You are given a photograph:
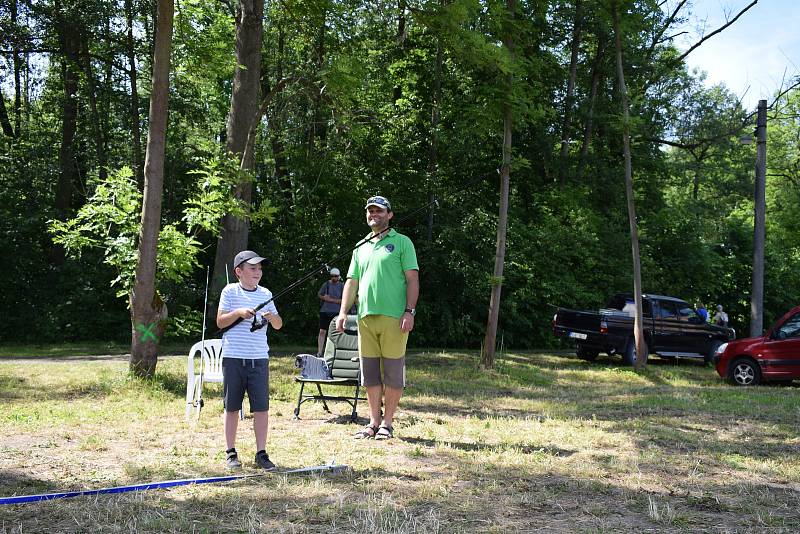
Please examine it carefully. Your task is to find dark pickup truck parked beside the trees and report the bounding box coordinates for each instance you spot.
[553,293,736,365]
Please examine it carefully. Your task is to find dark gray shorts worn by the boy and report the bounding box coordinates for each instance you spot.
[222,357,269,412]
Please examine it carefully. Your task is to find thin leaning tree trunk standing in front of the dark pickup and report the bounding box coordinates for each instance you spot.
[612,1,647,370]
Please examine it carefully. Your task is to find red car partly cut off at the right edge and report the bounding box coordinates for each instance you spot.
[712,306,800,386]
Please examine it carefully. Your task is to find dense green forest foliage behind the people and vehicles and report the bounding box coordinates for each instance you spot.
[0,0,800,358]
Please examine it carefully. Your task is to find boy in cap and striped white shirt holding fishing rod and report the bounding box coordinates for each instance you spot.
[217,250,283,470]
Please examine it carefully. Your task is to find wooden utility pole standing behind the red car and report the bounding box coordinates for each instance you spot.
[750,100,767,337]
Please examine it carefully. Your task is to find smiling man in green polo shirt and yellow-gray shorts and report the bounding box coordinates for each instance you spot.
[336,196,419,439]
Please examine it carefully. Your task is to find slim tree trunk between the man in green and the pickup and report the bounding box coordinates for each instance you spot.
[481,0,517,369]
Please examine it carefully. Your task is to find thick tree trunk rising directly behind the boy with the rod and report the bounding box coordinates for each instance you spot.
[211,0,264,302]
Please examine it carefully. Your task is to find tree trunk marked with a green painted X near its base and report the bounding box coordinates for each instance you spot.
[130,0,175,377]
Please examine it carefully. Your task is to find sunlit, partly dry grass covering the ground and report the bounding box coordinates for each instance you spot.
[0,349,800,533]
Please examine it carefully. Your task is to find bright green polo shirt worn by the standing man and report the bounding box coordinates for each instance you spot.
[347,229,419,319]
